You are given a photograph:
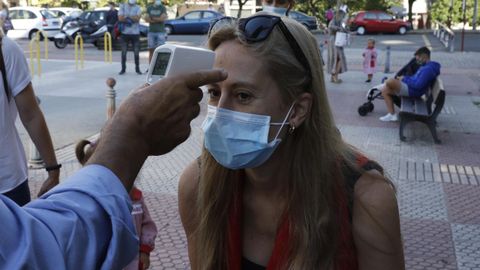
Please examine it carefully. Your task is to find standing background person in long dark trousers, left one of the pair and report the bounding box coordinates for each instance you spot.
[118,0,142,75]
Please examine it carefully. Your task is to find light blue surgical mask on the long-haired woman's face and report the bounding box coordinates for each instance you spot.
[202,104,294,170]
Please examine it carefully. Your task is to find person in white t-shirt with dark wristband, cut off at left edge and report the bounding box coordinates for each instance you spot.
[0,34,61,206]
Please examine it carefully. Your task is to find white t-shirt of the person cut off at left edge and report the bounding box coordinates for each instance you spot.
[0,37,31,193]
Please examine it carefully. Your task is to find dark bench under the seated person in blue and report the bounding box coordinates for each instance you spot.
[399,77,445,143]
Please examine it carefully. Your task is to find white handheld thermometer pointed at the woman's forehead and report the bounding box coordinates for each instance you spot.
[147,44,215,84]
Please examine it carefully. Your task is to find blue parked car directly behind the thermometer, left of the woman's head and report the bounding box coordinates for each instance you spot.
[165,10,224,34]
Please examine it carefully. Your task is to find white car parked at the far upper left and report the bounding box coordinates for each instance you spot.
[8,7,62,39]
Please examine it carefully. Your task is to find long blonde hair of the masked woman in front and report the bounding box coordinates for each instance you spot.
[194,17,376,269]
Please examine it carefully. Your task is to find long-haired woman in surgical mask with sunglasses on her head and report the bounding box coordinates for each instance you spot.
[179,14,404,270]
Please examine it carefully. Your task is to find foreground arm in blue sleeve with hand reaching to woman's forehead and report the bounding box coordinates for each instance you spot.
[0,70,227,270]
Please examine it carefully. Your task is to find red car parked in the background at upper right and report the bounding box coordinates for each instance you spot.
[349,11,411,35]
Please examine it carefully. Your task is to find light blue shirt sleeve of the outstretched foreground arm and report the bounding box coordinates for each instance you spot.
[0,165,139,270]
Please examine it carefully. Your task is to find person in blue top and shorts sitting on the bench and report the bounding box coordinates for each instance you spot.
[380,47,440,122]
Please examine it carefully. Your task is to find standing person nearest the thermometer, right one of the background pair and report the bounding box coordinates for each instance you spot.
[145,0,168,63]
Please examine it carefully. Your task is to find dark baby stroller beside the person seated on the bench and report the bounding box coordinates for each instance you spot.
[358,57,420,116]
